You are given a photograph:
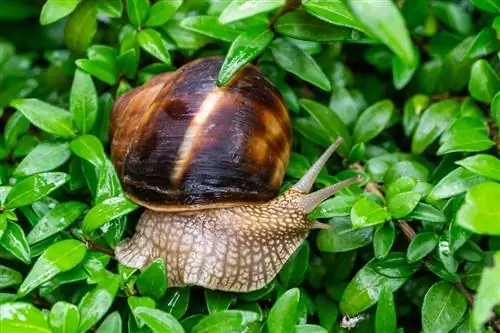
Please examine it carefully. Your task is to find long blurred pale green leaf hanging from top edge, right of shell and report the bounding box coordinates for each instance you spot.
[348,0,417,66]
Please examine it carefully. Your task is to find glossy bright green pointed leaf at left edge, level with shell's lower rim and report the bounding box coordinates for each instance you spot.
[5,172,69,208]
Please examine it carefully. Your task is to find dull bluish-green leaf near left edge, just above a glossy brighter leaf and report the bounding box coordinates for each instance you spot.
[12,142,71,178]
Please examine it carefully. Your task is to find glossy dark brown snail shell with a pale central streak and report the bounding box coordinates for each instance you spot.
[110,57,291,211]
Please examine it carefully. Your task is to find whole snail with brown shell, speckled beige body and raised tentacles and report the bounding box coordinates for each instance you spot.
[110,57,359,292]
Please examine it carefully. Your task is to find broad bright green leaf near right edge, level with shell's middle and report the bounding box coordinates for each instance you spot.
[437,117,495,155]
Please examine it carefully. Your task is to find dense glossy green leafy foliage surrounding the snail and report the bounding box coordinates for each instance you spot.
[0,0,500,333]
